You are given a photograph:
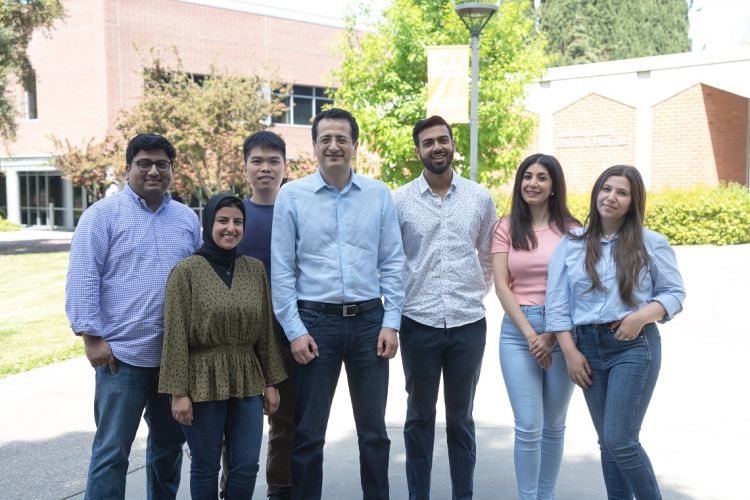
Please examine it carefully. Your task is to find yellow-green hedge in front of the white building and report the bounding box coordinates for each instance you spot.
[494,183,750,245]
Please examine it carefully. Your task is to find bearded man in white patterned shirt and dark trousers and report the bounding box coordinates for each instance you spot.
[393,116,497,500]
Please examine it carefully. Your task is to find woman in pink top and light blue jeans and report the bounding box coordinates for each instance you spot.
[492,154,580,500]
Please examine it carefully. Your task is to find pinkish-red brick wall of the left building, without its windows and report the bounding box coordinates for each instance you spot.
[11,0,342,156]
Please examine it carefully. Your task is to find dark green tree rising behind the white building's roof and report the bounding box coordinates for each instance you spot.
[540,0,690,66]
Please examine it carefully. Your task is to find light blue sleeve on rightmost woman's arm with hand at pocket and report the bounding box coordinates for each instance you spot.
[649,235,685,323]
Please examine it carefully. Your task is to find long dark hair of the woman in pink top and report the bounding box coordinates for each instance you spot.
[509,153,580,250]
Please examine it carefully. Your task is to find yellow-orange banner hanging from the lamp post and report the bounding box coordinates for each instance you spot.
[427,45,469,123]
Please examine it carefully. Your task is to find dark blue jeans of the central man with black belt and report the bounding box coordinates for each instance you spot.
[292,306,391,499]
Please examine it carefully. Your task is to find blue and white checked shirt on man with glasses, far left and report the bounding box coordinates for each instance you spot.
[65,185,201,367]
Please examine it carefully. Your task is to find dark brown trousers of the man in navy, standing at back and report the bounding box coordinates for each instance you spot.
[266,327,296,497]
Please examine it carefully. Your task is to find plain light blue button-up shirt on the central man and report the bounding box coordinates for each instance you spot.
[271,171,404,341]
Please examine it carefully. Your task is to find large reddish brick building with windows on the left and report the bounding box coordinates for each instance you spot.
[0,0,342,228]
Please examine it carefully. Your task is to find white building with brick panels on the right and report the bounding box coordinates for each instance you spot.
[526,48,750,191]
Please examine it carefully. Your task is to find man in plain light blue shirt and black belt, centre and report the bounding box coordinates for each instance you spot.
[271,108,404,499]
